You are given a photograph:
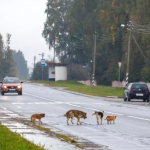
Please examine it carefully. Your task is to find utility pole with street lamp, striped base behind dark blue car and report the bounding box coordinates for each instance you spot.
[126,21,131,86]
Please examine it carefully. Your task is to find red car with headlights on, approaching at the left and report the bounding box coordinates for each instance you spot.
[0,77,23,95]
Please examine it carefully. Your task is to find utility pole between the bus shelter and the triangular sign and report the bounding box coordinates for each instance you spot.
[92,32,97,86]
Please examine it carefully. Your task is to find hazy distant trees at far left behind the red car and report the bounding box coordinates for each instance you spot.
[0,34,28,80]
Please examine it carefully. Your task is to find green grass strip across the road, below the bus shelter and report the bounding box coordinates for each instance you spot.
[32,81,124,97]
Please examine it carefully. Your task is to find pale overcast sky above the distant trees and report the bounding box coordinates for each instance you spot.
[0,0,53,67]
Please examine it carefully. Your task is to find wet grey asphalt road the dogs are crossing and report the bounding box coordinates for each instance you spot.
[0,84,150,150]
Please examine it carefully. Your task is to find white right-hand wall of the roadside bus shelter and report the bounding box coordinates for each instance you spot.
[55,66,67,81]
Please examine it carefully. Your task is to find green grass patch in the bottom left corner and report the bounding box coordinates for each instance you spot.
[0,124,44,150]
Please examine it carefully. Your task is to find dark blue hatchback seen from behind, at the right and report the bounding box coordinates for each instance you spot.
[124,83,149,102]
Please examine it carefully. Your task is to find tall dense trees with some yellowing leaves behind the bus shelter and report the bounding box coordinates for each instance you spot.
[42,0,150,85]
